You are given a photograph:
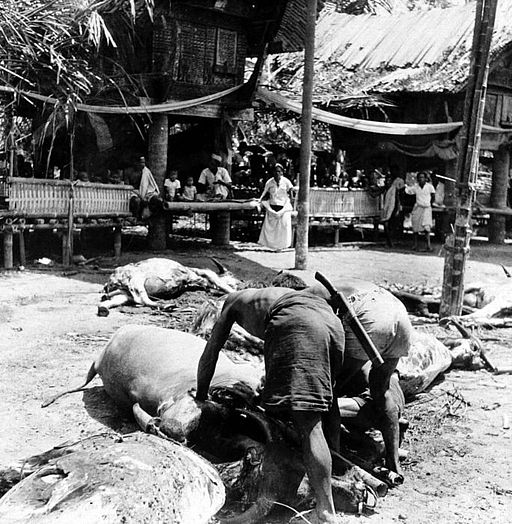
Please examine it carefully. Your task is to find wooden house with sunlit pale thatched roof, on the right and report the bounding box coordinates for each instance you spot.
[267,0,512,242]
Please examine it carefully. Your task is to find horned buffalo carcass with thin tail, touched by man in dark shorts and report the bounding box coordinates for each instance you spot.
[43,326,367,523]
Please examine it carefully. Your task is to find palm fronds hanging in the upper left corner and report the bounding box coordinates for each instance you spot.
[0,0,153,100]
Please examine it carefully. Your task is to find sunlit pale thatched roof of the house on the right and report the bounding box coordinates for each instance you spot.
[269,0,512,102]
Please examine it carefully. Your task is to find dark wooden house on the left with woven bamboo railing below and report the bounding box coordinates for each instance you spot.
[0,0,322,267]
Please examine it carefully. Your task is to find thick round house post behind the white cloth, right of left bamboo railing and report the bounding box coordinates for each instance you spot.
[148,113,169,251]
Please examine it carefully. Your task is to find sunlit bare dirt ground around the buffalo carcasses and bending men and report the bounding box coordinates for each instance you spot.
[0,235,512,524]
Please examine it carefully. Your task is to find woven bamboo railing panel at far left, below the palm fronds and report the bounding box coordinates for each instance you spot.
[8,178,133,218]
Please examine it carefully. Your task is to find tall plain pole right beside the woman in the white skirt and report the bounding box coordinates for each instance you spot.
[295,0,317,269]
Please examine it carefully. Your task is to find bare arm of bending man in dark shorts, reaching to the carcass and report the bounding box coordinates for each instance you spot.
[196,306,235,401]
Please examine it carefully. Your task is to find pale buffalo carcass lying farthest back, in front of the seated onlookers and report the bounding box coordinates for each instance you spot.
[98,258,240,316]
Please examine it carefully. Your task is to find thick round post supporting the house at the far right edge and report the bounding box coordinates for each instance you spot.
[489,146,510,244]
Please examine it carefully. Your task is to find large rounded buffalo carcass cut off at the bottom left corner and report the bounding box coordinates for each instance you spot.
[0,432,225,524]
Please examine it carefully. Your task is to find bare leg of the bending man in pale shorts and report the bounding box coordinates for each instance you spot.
[369,358,402,475]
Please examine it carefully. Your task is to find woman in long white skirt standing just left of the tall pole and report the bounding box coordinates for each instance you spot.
[258,163,293,249]
